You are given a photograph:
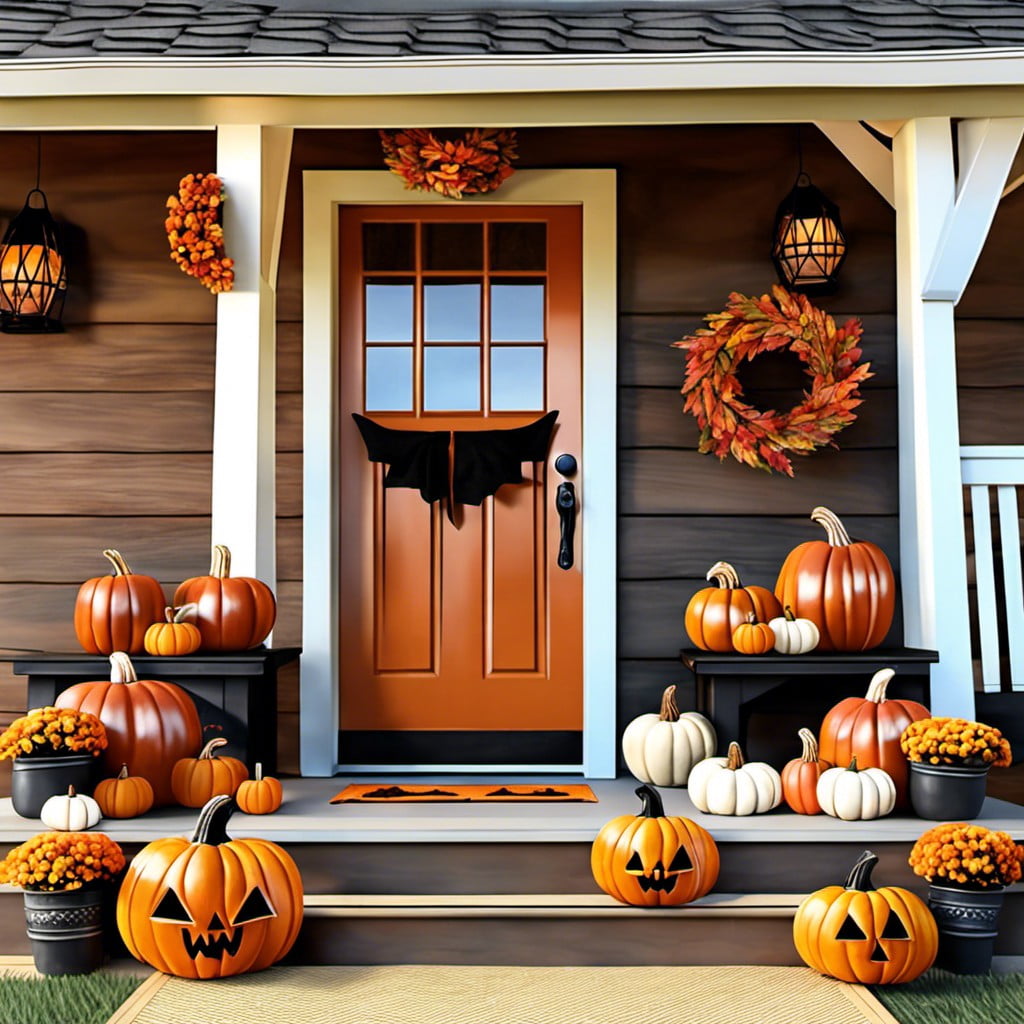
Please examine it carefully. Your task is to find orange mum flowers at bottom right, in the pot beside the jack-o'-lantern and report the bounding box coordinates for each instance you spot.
[908,821,1024,889]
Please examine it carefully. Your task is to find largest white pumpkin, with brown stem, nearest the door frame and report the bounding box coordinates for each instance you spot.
[623,686,718,785]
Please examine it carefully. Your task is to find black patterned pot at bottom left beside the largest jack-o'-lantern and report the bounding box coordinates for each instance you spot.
[25,888,103,974]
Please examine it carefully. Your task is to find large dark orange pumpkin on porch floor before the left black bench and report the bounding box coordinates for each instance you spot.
[55,651,203,807]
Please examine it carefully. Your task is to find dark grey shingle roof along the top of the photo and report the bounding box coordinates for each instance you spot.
[8,0,1024,58]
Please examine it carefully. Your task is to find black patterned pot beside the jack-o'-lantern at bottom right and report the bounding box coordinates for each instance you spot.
[928,886,1002,974]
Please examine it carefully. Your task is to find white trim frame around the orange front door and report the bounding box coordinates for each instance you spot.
[299,169,617,778]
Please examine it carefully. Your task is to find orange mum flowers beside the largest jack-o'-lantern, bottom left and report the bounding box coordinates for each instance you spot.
[0,831,125,892]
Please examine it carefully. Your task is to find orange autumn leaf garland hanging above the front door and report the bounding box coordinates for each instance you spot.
[380,128,518,199]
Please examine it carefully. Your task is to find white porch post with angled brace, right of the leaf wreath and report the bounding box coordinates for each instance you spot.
[893,118,1022,717]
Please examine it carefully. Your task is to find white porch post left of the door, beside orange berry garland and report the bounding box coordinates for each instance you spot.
[211,125,292,588]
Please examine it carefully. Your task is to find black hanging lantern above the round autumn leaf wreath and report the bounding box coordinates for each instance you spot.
[771,170,846,295]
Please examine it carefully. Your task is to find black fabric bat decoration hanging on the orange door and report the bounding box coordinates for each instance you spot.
[352,409,558,522]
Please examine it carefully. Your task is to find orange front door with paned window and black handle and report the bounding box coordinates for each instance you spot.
[339,203,585,764]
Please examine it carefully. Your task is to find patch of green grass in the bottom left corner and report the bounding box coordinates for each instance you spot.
[0,974,142,1024]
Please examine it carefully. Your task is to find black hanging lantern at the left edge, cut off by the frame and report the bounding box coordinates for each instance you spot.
[0,187,68,334]
